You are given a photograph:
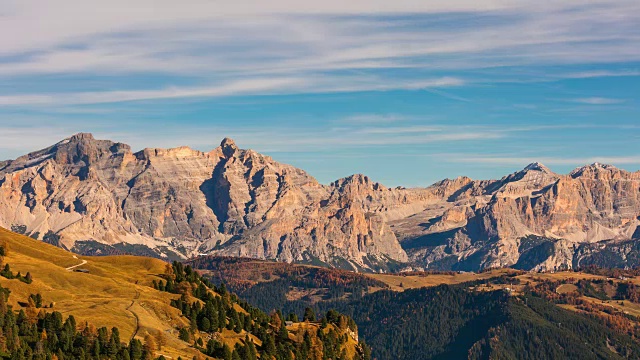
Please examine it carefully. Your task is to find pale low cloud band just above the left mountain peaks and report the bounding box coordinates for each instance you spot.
[0,122,508,155]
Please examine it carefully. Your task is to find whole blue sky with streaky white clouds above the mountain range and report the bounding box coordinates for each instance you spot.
[0,0,640,186]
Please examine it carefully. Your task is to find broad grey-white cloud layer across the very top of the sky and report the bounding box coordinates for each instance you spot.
[0,0,640,80]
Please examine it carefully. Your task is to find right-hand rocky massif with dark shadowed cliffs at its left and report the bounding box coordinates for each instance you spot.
[392,163,640,270]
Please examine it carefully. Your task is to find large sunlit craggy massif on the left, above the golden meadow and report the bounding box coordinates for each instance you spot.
[0,134,408,269]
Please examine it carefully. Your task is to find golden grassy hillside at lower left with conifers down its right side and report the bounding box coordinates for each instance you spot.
[0,228,362,360]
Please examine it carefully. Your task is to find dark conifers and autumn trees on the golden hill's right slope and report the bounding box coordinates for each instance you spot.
[153,263,365,360]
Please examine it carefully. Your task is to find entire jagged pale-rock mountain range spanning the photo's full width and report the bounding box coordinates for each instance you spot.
[0,134,640,270]
